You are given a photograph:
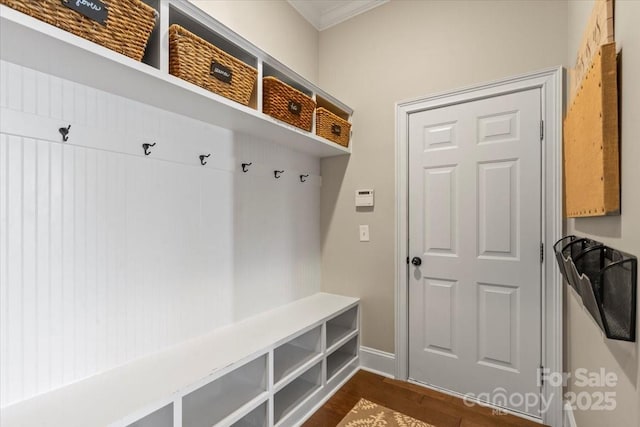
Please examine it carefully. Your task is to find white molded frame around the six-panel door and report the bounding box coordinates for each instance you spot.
[395,67,563,427]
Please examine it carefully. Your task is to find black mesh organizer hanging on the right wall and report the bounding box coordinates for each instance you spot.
[553,236,638,342]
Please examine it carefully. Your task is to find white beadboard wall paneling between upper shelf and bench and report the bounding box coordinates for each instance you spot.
[0,61,321,407]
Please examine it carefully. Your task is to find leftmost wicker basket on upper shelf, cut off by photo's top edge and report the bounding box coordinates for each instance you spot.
[0,0,156,61]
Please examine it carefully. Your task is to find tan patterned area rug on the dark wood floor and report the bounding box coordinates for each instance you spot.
[337,399,434,427]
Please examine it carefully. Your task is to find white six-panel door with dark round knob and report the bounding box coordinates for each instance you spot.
[409,89,542,417]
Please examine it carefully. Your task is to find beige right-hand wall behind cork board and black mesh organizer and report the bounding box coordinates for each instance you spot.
[565,0,640,427]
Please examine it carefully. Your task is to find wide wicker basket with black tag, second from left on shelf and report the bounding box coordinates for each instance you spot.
[169,24,258,105]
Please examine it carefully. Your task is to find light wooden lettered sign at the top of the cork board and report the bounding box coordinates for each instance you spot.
[568,0,614,105]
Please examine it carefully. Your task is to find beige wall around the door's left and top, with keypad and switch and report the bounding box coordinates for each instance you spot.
[319,1,567,353]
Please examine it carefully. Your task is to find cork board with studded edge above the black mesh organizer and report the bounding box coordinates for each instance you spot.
[564,43,620,217]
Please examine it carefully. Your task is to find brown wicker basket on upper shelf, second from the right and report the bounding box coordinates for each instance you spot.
[262,77,316,132]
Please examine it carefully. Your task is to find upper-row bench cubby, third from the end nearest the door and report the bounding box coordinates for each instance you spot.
[182,354,267,427]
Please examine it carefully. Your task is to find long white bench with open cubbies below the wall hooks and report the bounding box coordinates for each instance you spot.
[0,293,359,427]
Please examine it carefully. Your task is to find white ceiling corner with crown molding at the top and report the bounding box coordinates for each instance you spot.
[287,0,389,31]
